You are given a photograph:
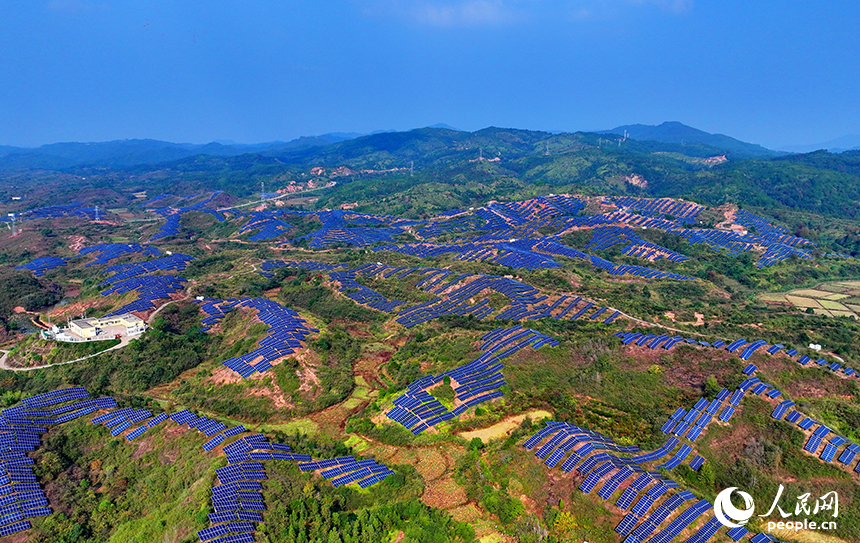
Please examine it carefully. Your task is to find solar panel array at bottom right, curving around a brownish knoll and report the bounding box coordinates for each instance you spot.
[523,377,860,543]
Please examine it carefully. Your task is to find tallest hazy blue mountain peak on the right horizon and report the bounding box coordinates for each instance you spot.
[600,121,784,156]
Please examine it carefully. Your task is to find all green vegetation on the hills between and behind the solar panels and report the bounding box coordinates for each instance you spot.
[0,128,860,543]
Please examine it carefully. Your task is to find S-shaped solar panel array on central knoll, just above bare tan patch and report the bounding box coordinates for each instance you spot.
[385,325,558,435]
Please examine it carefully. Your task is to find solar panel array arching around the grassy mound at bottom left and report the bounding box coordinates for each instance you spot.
[0,387,402,543]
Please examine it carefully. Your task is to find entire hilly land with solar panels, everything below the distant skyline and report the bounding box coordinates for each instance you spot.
[0,129,860,543]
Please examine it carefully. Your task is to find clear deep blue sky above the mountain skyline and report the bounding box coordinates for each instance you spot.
[0,0,860,147]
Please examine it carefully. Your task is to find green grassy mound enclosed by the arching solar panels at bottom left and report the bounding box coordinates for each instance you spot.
[36,420,218,543]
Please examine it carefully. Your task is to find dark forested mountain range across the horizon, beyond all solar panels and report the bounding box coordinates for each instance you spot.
[0,123,860,224]
